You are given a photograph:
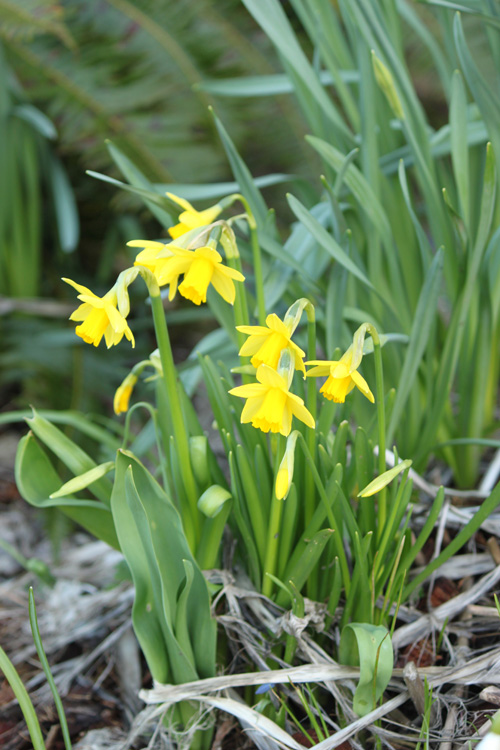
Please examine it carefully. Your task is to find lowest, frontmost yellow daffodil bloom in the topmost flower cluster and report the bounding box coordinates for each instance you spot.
[163,245,245,305]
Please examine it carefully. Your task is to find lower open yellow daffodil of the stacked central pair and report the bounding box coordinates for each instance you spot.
[229,365,315,436]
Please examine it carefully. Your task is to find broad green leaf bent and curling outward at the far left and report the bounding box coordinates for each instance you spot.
[15,433,120,549]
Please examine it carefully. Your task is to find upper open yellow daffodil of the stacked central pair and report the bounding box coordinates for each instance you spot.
[237,313,306,374]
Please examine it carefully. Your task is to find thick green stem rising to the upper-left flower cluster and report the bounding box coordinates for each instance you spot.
[150,290,200,552]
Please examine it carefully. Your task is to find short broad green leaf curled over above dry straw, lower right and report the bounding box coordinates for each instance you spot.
[339,622,394,716]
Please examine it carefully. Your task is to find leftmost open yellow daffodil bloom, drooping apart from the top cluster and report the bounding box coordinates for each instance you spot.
[63,279,135,349]
